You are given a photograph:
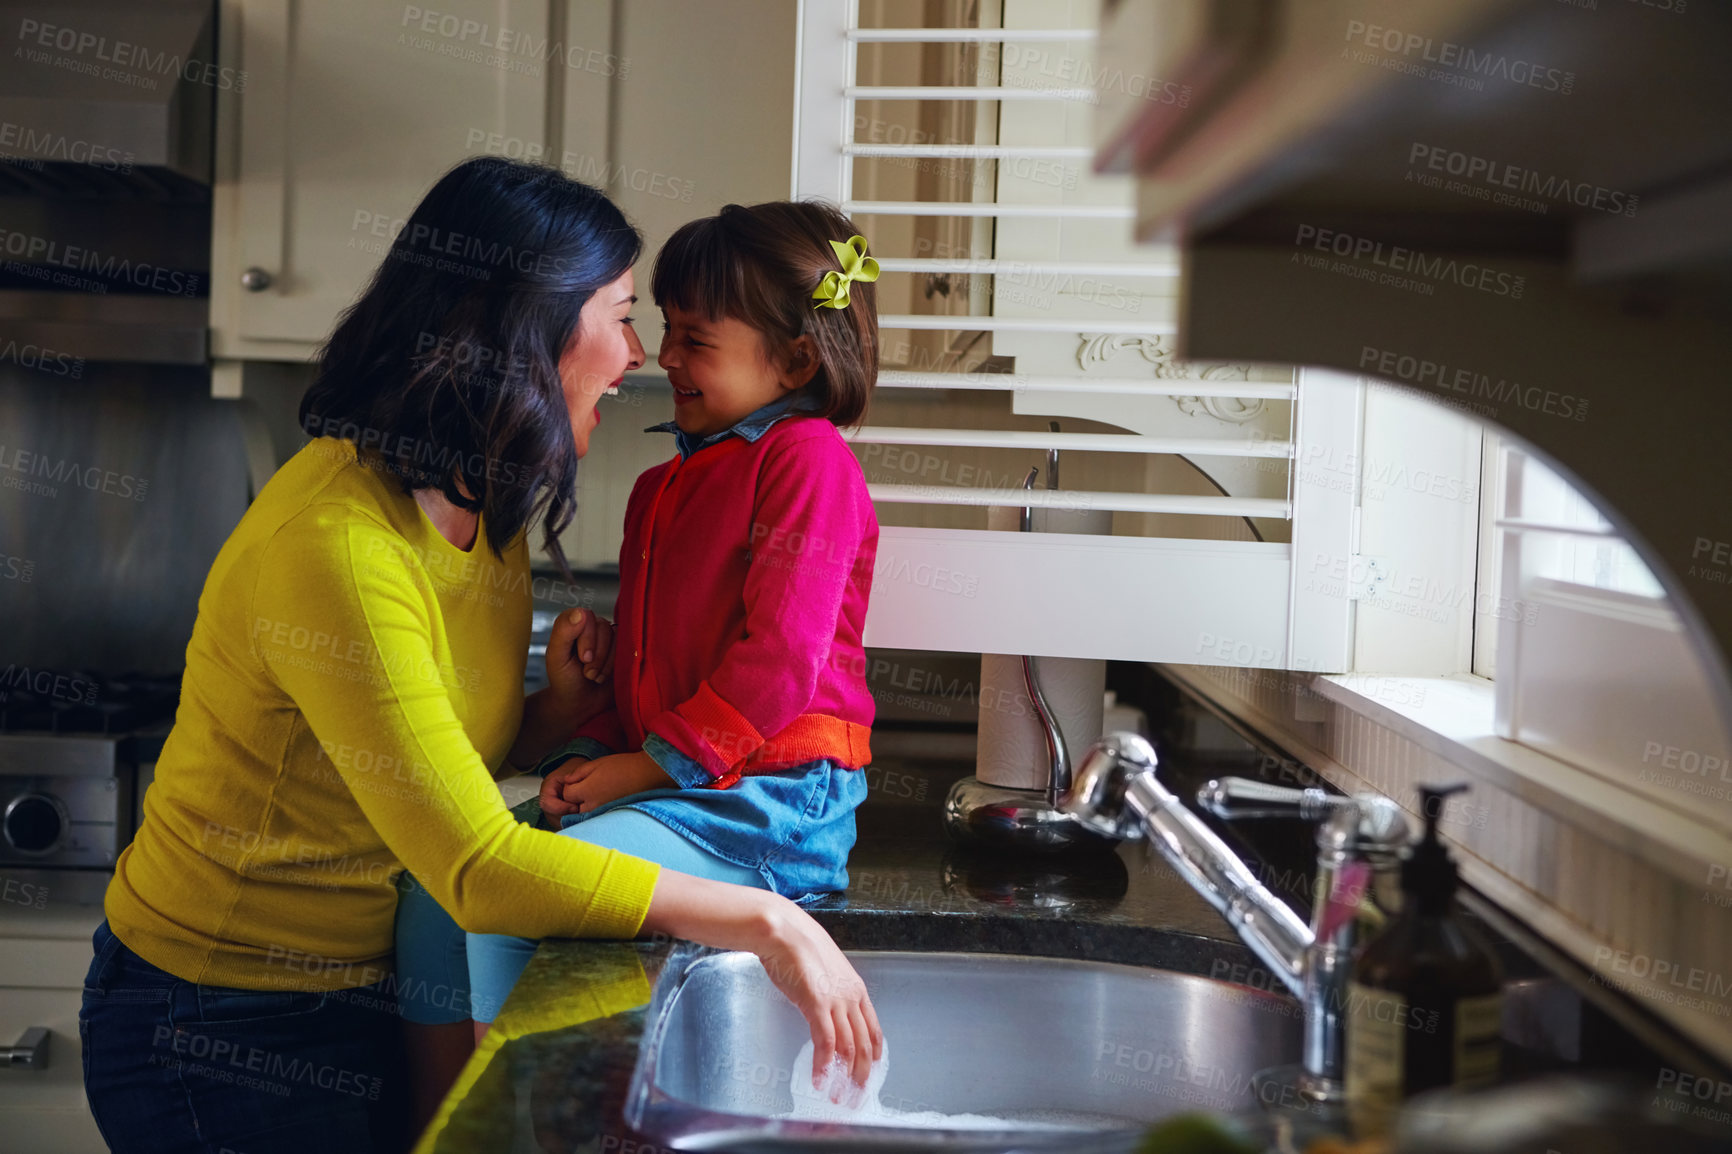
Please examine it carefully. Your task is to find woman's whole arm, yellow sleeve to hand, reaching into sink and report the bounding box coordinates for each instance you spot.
[251,518,876,1081]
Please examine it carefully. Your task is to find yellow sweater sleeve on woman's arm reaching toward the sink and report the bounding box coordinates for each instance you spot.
[251,513,656,937]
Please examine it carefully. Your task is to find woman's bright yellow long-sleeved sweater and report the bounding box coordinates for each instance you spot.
[106,437,656,989]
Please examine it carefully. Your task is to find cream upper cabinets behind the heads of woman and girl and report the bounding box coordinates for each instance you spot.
[211,0,793,363]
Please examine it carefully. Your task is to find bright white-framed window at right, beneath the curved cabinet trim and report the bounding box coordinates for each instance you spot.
[1354,395,1732,825]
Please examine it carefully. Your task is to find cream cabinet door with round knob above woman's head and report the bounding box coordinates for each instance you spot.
[211,0,547,359]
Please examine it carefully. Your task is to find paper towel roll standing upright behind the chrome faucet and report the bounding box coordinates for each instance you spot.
[975,506,1112,790]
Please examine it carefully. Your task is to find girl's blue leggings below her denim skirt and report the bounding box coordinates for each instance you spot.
[397,807,767,1026]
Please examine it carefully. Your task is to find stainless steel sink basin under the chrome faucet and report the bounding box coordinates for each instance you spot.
[627,948,1301,1151]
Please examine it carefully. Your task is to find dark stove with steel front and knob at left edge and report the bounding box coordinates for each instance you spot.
[0,665,180,880]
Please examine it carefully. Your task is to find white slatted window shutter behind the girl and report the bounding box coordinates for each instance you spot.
[792,0,1361,671]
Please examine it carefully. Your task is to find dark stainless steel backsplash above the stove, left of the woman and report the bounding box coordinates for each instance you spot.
[0,362,249,674]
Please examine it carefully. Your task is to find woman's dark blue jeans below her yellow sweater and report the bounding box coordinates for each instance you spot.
[78,922,412,1154]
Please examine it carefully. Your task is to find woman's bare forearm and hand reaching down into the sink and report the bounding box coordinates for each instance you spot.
[643,870,883,1104]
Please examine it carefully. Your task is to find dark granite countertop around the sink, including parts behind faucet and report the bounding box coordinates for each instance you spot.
[417,665,1708,1154]
